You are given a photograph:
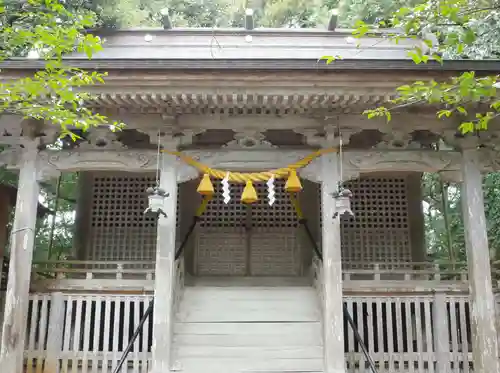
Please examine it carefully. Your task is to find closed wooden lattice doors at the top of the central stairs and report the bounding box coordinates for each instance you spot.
[193,180,305,276]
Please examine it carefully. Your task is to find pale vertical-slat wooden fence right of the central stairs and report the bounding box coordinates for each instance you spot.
[344,294,472,373]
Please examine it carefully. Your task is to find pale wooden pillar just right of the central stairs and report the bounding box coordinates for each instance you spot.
[321,154,345,373]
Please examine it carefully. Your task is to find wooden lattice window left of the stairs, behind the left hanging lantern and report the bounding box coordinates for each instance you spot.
[87,172,179,261]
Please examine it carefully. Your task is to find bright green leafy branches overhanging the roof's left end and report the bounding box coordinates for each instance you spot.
[0,0,120,136]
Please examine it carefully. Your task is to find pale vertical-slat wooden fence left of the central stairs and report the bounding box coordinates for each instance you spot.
[25,293,152,373]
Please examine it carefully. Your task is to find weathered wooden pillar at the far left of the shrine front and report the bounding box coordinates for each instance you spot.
[0,144,40,373]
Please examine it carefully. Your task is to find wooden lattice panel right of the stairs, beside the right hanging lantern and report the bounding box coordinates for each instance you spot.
[341,176,411,263]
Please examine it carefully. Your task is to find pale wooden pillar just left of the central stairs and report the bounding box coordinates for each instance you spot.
[149,155,177,373]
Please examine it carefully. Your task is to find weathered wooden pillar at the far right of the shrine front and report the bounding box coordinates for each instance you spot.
[462,149,500,373]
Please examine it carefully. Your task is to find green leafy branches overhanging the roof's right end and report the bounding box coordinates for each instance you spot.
[355,0,500,133]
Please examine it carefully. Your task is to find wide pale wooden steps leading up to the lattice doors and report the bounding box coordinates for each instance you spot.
[172,278,323,373]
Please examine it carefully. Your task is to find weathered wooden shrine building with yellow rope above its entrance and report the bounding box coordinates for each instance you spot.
[0,24,500,373]
